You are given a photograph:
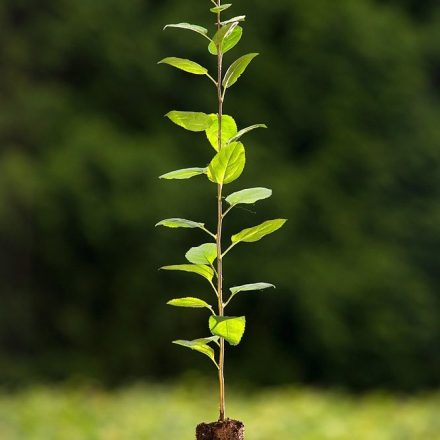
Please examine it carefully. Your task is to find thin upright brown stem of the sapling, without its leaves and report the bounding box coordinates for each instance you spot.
[216,0,225,421]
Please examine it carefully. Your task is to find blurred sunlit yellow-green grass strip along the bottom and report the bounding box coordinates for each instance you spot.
[0,385,440,440]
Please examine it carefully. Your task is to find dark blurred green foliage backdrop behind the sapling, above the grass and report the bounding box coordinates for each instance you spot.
[0,0,440,389]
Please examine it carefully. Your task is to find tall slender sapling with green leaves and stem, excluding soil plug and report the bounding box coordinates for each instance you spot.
[156,0,286,421]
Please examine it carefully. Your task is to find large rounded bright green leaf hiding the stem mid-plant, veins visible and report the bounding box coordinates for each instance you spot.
[207,142,246,184]
